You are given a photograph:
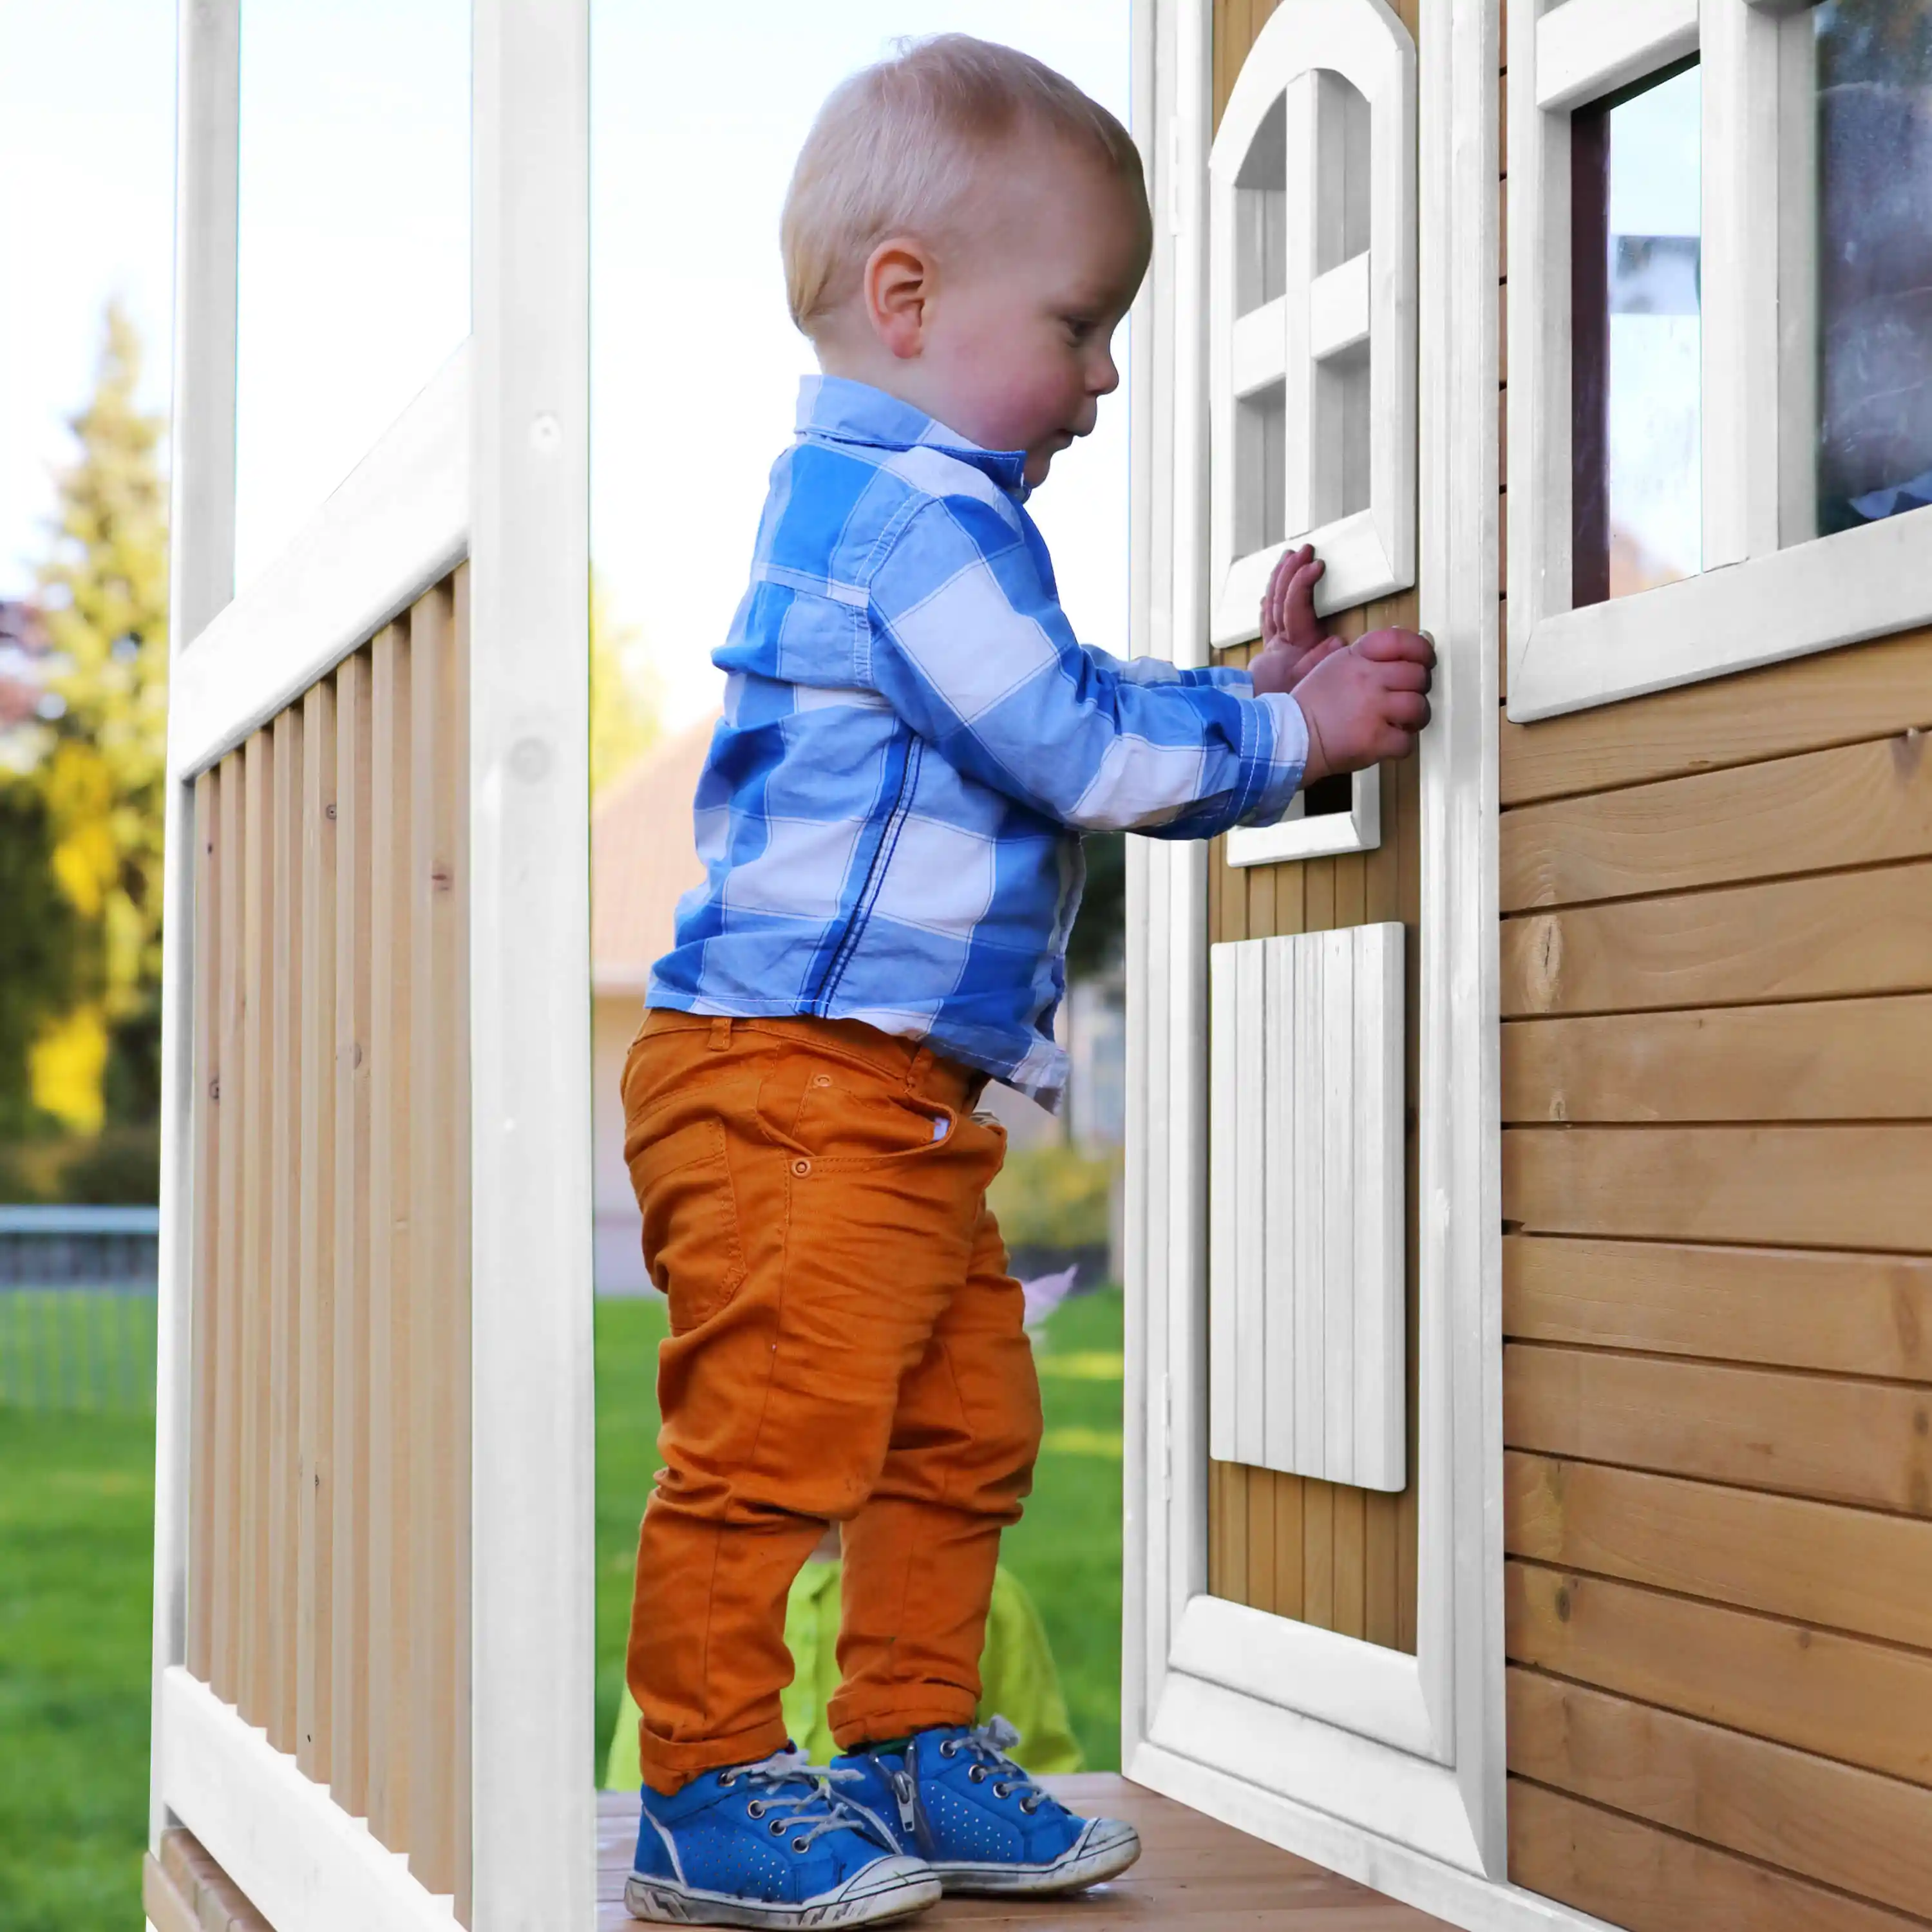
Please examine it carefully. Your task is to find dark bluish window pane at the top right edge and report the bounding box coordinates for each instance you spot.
[1812,0,1932,535]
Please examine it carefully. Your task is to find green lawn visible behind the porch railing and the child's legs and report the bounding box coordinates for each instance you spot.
[0,1294,1121,1932]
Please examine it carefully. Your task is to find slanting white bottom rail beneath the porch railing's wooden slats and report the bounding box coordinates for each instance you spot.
[156,1665,456,1932]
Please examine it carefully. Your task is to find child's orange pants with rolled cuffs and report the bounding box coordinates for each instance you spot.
[624,1010,1039,1793]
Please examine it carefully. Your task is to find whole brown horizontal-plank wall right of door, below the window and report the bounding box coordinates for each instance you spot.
[1497,23,1932,1932]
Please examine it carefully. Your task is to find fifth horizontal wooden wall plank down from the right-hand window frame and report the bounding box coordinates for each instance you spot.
[1503,1121,1932,1252]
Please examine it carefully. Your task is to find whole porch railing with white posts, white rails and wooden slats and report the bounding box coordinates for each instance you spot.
[151,0,595,1932]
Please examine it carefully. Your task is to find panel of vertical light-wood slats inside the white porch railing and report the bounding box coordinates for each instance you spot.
[187,570,469,1922]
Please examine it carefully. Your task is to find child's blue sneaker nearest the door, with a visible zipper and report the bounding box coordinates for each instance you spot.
[833,1718,1140,1897]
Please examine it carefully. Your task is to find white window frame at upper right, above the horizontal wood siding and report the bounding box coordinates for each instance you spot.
[1509,0,1932,723]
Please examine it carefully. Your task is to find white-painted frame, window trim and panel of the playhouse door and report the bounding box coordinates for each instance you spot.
[1122,0,1578,1926]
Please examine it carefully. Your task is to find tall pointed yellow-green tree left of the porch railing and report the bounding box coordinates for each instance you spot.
[31,303,168,1132]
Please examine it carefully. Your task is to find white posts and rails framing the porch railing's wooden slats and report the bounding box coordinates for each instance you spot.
[149,0,597,1932]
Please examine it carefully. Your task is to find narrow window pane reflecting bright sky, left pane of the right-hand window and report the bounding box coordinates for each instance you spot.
[1571,64,1704,605]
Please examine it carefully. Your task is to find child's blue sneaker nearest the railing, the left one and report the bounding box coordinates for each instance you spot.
[624,1750,939,1926]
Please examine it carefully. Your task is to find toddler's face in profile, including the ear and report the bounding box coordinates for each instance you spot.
[846,137,1150,485]
